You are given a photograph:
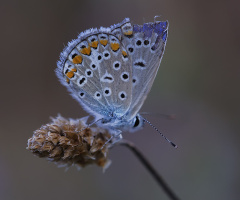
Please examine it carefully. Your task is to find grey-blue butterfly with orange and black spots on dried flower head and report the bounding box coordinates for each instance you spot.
[56,18,176,148]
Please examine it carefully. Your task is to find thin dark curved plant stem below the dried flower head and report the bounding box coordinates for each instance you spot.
[117,140,179,200]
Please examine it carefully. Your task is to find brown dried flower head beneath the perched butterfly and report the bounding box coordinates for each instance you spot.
[27,116,111,169]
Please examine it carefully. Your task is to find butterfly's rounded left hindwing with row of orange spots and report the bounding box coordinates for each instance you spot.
[56,24,132,118]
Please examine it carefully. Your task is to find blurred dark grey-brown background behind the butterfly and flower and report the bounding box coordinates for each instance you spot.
[0,0,240,200]
